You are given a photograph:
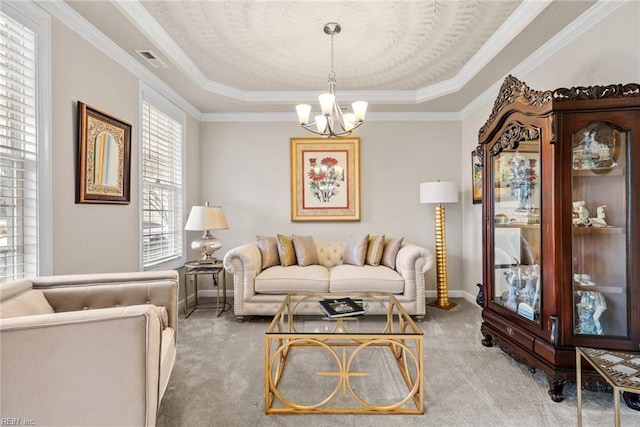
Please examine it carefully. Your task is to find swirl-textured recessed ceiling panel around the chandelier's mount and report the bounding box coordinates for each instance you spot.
[143,0,521,91]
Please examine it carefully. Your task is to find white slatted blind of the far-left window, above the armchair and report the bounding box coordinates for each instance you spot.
[0,13,39,282]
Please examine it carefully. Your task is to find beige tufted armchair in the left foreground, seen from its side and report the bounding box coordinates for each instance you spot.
[0,271,178,426]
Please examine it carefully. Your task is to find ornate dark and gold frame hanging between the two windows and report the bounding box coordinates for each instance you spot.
[76,101,131,204]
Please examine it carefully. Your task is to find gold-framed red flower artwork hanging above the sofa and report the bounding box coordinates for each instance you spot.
[291,137,360,221]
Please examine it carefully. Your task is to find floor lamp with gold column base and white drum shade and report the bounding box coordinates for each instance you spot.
[420,181,458,310]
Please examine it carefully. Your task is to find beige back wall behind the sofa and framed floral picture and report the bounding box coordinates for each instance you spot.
[200,118,462,296]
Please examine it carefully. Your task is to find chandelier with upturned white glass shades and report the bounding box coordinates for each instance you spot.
[296,22,368,138]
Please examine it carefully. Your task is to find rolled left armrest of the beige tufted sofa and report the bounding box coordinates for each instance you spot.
[223,243,262,315]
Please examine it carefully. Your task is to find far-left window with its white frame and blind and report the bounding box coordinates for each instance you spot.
[0,4,51,282]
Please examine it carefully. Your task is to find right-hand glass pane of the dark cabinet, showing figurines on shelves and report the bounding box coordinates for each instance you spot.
[571,122,628,337]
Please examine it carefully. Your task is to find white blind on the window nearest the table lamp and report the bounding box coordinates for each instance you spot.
[142,101,183,268]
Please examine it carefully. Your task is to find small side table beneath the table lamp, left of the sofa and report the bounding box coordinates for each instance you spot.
[184,260,231,319]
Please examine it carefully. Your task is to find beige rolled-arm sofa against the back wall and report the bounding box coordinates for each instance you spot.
[224,237,434,321]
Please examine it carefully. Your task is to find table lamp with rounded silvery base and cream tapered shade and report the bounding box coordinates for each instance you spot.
[184,202,229,264]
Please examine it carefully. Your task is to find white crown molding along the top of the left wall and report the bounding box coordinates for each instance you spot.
[35,0,202,119]
